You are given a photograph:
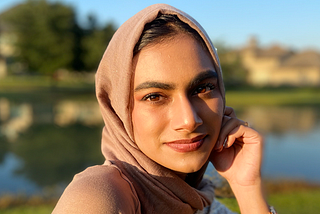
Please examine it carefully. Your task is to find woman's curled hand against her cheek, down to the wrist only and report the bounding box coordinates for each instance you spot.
[210,107,263,186]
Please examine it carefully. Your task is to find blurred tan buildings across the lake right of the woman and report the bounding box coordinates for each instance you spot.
[238,38,320,86]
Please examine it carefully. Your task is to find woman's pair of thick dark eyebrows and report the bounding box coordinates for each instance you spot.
[134,70,218,92]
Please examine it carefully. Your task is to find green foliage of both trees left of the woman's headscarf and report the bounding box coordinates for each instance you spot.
[0,0,115,75]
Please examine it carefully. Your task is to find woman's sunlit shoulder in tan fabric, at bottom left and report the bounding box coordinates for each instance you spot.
[53,165,140,213]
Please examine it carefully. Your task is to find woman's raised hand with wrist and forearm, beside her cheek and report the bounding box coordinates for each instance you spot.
[209,107,268,214]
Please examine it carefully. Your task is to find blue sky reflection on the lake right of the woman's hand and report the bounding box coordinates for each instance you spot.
[263,125,320,183]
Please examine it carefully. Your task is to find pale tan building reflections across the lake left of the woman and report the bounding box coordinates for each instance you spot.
[0,98,102,142]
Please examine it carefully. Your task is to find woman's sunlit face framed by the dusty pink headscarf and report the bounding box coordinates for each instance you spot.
[132,34,223,177]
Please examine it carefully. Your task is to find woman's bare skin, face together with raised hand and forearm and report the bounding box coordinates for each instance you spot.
[132,34,268,214]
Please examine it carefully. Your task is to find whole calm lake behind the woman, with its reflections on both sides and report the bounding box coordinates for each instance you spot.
[0,93,320,195]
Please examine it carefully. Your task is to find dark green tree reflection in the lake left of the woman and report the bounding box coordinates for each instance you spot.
[12,124,103,186]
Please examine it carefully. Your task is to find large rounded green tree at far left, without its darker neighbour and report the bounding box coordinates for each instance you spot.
[1,0,81,74]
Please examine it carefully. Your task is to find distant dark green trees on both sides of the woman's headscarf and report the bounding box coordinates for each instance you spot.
[0,0,247,86]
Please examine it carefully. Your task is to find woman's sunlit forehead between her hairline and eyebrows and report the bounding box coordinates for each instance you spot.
[133,34,215,85]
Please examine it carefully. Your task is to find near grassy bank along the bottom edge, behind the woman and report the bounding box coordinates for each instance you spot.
[0,180,320,214]
